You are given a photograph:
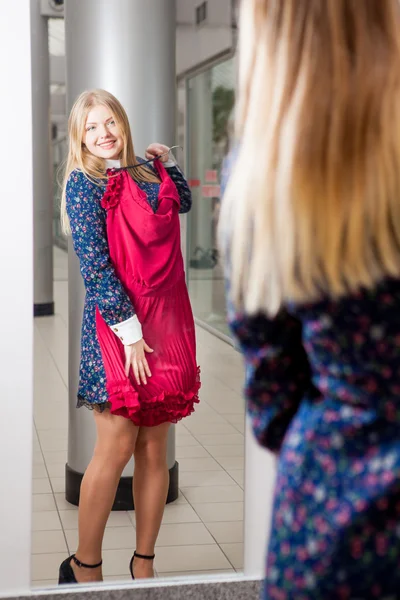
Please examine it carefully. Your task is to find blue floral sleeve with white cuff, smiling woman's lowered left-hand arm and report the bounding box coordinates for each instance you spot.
[66,171,135,326]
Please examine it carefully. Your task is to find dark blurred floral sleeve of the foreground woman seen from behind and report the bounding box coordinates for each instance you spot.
[228,305,316,452]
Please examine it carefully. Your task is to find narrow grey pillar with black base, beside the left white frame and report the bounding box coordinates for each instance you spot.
[30,0,54,317]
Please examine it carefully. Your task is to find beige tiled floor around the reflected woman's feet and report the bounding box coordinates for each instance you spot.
[32,249,244,587]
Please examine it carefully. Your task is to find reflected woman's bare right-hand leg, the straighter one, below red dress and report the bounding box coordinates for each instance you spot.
[133,423,170,579]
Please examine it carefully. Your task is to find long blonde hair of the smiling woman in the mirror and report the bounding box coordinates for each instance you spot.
[61,90,159,234]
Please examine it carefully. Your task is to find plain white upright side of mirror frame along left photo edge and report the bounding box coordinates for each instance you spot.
[0,0,33,596]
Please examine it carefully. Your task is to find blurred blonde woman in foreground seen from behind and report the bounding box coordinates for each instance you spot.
[220,0,400,600]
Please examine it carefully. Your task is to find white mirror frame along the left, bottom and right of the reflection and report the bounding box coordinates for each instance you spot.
[0,0,274,600]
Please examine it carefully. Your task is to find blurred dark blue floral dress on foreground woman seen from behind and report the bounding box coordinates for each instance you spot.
[222,155,400,600]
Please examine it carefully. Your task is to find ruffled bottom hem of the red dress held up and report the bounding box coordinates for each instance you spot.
[107,367,201,427]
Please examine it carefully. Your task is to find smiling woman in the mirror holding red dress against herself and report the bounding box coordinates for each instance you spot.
[59,90,200,583]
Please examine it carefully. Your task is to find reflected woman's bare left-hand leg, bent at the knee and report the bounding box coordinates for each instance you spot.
[71,409,139,582]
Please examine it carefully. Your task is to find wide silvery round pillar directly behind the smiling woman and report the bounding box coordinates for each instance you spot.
[65,0,178,510]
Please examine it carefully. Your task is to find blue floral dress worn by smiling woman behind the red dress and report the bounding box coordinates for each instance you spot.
[66,159,192,410]
